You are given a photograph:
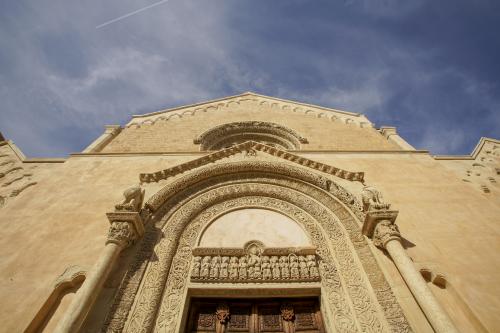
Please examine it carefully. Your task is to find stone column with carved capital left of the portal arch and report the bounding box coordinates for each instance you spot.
[55,211,144,333]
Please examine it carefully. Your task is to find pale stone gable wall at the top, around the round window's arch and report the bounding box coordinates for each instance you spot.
[102,93,400,152]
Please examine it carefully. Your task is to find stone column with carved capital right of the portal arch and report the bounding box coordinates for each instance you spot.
[363,210,458,333]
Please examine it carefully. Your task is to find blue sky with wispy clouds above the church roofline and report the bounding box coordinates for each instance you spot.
[0,0,500,157]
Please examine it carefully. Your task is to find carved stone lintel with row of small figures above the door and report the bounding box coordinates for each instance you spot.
[191,241,320,283]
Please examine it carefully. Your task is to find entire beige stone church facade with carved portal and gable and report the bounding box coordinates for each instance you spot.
[0,93,500,333]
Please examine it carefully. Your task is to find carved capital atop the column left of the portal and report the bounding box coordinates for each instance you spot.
[106,212,144,247]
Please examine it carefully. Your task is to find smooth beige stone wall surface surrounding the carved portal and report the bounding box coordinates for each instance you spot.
[0,97,500,332]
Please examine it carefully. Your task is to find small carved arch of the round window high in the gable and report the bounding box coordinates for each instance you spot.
[194,121,307,150]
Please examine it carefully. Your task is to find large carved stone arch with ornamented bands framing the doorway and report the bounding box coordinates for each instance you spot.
[105,161,410,332]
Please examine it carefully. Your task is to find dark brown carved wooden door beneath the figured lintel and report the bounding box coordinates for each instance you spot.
[186,298,324,333]
